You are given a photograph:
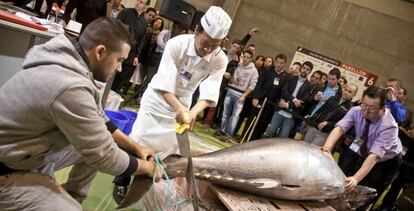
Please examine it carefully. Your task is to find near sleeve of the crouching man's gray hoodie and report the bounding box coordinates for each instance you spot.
[48,86,133,175]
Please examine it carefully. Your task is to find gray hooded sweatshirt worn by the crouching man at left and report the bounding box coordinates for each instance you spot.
[0,35,130,175]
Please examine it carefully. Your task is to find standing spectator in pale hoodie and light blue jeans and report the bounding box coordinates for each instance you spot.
[219,50,259,138]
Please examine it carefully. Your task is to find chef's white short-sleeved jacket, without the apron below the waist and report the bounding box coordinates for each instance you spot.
[140,34,228,118]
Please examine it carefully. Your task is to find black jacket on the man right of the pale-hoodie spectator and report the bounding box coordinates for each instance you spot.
[253,68,287,102]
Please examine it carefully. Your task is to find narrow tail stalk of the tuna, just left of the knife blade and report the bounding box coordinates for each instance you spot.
[163,154,188,179]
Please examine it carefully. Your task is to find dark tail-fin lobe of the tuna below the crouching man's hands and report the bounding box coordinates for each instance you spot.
[117,175,152,209]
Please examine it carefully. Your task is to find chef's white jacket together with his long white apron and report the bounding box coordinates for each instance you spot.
[130,34,228,152]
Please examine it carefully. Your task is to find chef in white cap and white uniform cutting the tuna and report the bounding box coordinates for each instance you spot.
[115,6,232,198]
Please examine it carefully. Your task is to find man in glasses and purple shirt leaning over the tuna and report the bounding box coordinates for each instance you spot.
[322,86,402,208]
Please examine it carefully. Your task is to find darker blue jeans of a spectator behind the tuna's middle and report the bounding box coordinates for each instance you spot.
[264,111,295,138]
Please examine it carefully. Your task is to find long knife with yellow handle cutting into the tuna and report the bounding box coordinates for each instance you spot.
[176,125,199,211]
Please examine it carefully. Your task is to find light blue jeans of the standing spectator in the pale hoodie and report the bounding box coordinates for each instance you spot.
[220,92,243,137]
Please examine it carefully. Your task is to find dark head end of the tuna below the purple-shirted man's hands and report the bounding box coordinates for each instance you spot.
[327,185,377,210]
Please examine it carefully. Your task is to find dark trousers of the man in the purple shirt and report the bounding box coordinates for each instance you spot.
[338,146,402,203]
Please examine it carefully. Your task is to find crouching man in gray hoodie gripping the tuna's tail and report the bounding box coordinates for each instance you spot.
[0,18,162,210]
